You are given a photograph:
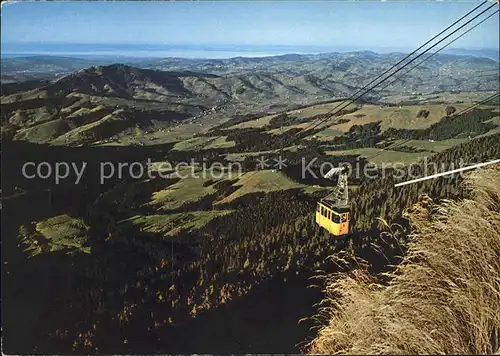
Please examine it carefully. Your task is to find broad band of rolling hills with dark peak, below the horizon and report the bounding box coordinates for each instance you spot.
[1,52,498,144]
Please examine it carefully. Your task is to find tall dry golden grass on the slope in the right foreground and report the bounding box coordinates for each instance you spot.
[306,166,500,355]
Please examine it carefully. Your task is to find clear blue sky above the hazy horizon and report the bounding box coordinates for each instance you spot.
[1,1,499,55]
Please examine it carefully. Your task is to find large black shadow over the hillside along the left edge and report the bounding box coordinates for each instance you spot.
[1,140,171,353]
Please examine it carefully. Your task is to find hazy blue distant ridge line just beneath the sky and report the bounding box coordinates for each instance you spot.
[1,49,498,83]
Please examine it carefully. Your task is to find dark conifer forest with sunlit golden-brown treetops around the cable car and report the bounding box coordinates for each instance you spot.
[4,134,500,352]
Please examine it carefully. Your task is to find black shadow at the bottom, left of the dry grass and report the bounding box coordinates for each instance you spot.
[154,274,322,354]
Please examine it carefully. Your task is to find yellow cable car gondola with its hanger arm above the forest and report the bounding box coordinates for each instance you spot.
[316,167,350,236]
